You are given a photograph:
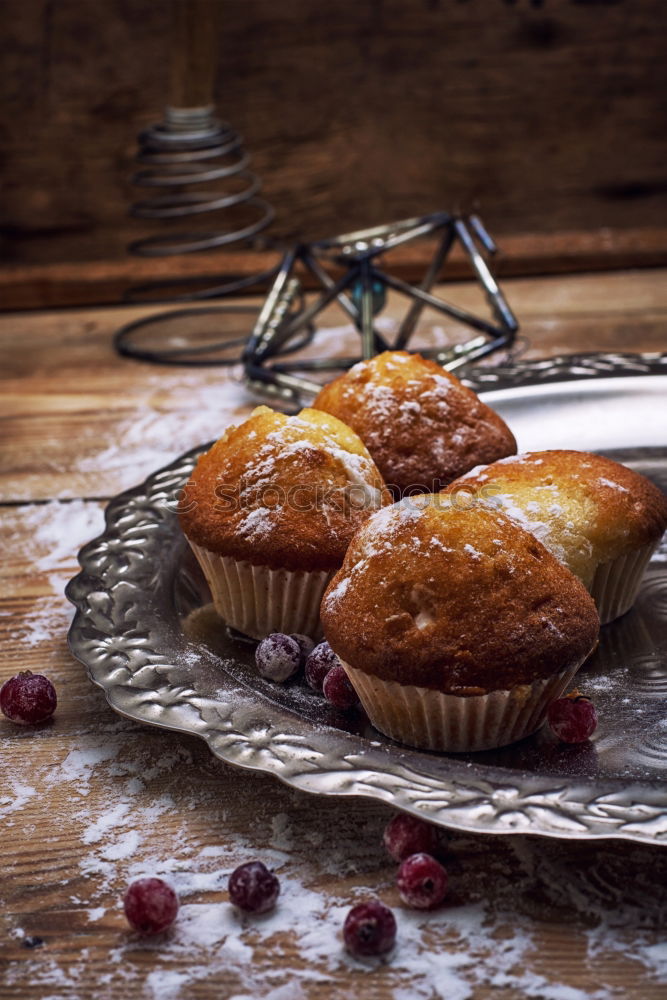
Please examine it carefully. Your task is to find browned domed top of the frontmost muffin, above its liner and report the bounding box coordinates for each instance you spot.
[321,494,599,695]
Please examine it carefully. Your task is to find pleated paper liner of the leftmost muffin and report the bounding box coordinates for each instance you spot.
[190,542,333,639]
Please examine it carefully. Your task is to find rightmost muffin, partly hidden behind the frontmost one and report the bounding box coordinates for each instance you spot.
[449,451,667,625]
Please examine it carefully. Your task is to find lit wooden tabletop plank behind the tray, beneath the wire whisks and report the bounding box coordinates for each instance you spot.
[0,270,667,501]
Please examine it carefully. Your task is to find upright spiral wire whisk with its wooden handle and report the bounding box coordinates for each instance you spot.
[114,0,279,366]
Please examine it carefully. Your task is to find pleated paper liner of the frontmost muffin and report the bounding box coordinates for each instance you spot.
[343,660,583,753]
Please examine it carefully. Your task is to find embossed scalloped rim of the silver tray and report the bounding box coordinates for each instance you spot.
[66,354,667,844]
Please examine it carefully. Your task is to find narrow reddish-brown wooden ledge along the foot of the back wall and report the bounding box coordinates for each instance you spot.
[0,229,667,310]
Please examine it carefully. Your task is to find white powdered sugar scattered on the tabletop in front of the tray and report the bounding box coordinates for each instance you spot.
[2,720,667,1000]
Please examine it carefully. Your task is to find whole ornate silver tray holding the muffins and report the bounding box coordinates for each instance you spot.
[66,354,667,844]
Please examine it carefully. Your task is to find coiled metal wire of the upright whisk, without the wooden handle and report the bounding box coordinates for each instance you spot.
[114,107,279,365]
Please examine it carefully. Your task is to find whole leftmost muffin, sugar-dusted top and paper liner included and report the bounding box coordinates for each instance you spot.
[179,406,391,639]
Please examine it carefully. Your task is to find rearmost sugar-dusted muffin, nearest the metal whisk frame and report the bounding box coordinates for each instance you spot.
[313,351,516,496]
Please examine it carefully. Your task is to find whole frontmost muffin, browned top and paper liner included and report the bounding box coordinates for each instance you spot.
[321,494,599,751]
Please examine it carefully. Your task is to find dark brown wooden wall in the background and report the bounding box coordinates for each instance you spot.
[0,0,667,307]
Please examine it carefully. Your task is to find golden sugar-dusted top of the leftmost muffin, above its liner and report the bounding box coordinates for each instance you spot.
[179,406,391,571]
